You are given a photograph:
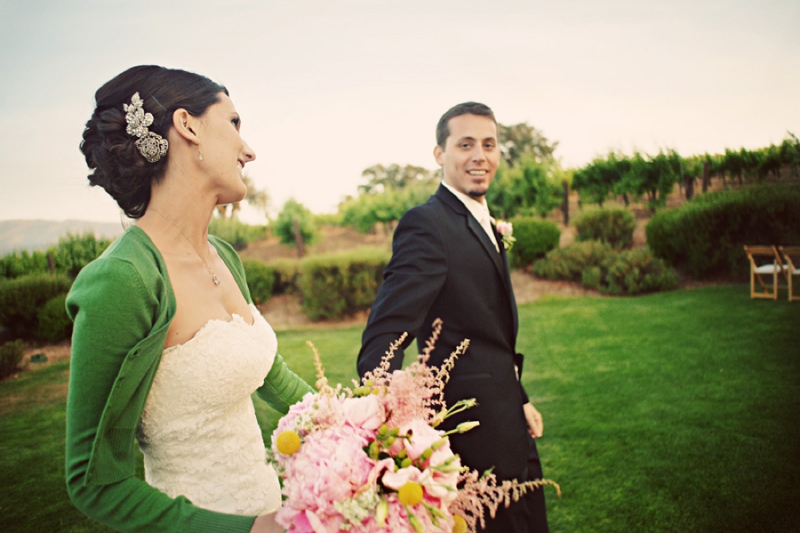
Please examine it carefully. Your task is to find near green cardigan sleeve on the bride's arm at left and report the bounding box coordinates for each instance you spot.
[66,257,254,533]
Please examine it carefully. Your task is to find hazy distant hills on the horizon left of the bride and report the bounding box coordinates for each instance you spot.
[0,220,124,255]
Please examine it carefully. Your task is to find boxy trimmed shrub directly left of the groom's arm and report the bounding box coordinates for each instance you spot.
[300,248,390,320]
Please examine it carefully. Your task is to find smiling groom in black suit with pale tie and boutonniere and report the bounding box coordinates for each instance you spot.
[358,102,548,533]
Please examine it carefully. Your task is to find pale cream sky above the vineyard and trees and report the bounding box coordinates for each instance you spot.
[0,0,800,222]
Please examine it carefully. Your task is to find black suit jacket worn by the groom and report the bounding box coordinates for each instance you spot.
[358,186,528,479]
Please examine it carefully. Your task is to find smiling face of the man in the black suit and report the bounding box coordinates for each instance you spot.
[433,114,500,200]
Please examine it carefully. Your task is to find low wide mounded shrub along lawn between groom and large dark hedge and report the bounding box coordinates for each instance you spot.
[533,241,678,295]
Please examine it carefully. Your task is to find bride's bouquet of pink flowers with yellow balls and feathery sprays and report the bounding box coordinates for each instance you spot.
[272,321,558,533]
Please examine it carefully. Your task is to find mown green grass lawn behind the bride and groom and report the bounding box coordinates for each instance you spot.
[0,286,800,533]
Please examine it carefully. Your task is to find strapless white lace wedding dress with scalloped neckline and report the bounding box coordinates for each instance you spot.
[133,306,281,515]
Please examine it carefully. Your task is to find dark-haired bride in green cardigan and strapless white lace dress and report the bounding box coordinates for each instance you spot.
[66,66,311,533]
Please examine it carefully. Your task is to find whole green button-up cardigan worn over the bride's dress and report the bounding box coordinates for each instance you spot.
[66,226,312,533]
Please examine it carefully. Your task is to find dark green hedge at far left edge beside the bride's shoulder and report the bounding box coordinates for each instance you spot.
[0,274,72,337]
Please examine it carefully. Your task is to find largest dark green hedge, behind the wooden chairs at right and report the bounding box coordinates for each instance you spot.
[646,185,800,279]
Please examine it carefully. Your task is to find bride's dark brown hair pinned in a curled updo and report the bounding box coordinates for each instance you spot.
[81,65,228,218]
